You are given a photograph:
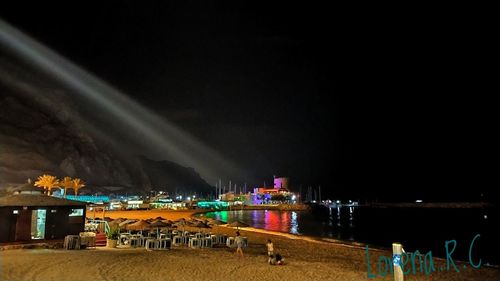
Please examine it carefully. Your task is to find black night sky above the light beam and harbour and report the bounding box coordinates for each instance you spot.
[0,1,498,198]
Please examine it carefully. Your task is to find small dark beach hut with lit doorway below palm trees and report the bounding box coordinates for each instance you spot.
[0,189,86,243]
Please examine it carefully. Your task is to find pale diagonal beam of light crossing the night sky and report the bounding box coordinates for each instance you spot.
[0,19,243,182]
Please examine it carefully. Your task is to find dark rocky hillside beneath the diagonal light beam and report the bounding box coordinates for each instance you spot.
[0,53,211,194]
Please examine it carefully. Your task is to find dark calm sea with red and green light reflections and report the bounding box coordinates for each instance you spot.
[201,207,500,265]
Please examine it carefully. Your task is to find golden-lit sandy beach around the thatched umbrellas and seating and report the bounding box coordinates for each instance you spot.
[0,211,500,281]
